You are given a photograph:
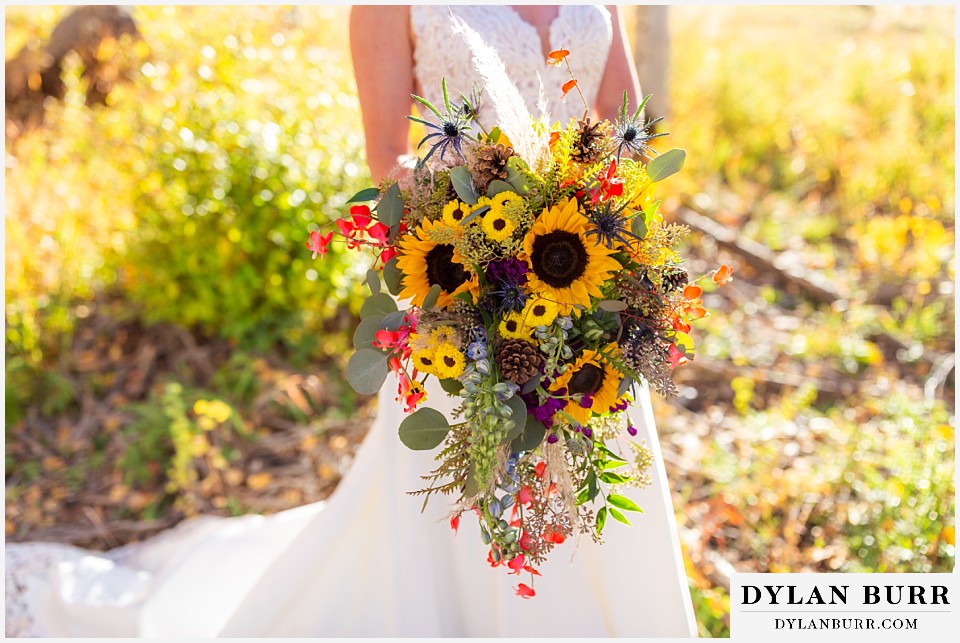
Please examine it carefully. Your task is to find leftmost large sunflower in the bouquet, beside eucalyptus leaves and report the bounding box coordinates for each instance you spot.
[397,219,479,307]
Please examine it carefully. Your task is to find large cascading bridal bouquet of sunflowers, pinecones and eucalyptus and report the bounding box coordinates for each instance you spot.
[307,45,730,597]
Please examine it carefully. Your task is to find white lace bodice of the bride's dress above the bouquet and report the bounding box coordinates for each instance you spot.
[410,5,613,126]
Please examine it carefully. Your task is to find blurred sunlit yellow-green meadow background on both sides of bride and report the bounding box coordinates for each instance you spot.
[5,6,955,636]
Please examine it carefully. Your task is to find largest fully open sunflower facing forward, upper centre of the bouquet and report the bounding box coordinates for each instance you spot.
[520,199,621,315]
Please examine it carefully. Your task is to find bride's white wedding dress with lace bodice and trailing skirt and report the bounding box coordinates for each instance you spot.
[6,6,697,637]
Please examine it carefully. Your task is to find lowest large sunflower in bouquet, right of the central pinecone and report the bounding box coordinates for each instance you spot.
[550,344,623,425]
